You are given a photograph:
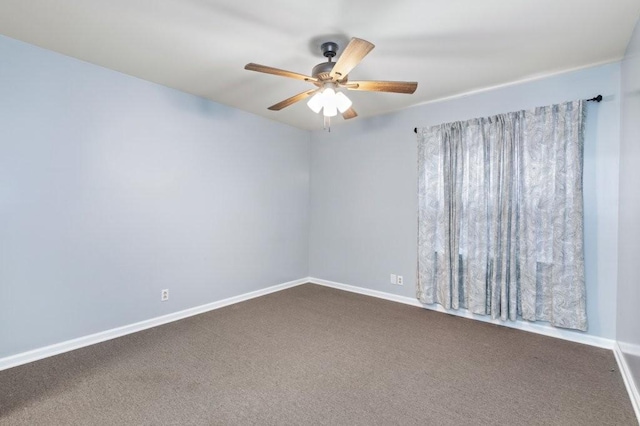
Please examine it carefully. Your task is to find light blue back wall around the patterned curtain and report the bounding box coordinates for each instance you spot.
[309,64,620,338]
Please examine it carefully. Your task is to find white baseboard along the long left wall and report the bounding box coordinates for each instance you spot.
[0,278,308,371]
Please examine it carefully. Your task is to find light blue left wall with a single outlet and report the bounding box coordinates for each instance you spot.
[0,36,310,357]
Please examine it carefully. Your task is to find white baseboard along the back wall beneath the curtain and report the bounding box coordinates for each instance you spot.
[307,277,615,349]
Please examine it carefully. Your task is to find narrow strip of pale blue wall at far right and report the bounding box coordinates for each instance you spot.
[617,18,640,388]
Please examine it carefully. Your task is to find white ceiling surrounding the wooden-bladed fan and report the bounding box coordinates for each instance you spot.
[0,0,640,129]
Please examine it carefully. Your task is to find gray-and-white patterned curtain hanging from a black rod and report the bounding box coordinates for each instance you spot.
[417,101,587,330]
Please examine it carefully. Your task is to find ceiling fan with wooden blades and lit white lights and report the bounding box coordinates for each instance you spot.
[244,37,418,130]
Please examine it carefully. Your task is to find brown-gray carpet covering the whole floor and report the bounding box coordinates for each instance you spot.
[0,284,637,425]
